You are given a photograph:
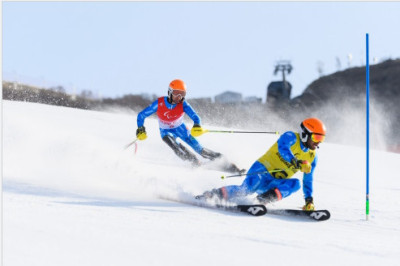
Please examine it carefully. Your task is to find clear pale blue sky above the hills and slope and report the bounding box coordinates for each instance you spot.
[2,2,400,101]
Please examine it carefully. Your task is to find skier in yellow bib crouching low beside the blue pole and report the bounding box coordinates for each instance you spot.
[197,118,326,211]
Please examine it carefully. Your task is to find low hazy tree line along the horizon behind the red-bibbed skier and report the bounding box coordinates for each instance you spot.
[3,81,282,131]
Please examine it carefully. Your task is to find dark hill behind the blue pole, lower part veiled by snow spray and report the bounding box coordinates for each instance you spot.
[290,59,400,151]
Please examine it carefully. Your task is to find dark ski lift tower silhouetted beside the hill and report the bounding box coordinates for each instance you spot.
[267,60,293,107]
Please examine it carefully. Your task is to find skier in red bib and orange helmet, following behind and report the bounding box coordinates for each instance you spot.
[136,79,245,173]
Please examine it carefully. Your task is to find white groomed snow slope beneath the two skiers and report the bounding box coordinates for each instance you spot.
[2,101,400,266]
